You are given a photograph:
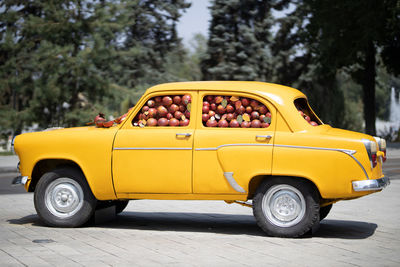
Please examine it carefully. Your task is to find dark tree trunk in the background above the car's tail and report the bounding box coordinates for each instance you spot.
[362,41,376,135]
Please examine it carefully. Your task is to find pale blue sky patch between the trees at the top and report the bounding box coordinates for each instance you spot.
[177,0,211,46]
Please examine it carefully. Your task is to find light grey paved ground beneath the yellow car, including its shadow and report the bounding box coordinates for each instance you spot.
[0,149,400,266]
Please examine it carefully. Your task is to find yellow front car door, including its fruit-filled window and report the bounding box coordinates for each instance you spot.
[112,91,197,196]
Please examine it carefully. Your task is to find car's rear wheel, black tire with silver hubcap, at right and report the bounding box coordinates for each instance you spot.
[253,177,319,237]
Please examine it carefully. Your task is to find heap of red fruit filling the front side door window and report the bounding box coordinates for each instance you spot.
[133,95,192,127]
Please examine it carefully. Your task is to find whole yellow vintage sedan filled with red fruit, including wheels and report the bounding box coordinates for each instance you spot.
[14,81,389,237]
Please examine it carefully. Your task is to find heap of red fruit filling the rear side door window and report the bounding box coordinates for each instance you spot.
[202,95,271,128]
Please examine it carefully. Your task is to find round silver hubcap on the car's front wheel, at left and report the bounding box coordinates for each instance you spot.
[45,178,83,218]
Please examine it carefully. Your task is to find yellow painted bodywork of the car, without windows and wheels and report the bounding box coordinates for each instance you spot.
[15,82,383,202]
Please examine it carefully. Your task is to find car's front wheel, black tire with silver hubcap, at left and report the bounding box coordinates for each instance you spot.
[34,168,97,227]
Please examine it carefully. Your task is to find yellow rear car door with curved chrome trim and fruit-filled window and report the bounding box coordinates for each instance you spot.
[193,91,276,194]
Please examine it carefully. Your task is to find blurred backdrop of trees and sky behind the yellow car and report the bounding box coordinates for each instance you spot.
[0,0,400,153]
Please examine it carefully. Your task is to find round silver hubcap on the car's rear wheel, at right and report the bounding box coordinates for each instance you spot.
[262,184,306,227]
